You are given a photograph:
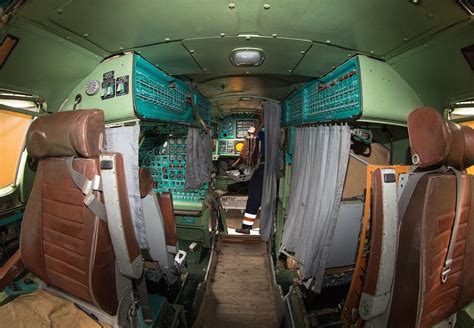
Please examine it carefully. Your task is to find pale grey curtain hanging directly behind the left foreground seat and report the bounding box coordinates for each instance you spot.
[106,124,149,249]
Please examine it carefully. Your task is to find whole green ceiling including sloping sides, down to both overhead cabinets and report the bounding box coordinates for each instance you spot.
[0,0,472,110]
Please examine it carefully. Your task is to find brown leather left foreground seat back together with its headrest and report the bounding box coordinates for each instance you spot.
[20,110,139,314]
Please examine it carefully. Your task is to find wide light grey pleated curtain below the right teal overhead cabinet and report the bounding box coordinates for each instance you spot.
[282,125,351,293]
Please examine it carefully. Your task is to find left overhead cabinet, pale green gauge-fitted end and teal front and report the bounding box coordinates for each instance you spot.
[59,52,211,126]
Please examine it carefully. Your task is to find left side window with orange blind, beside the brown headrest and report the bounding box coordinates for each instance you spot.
[0,92,39,197]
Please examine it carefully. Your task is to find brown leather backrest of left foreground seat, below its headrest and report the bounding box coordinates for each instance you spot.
[20,158,117,314]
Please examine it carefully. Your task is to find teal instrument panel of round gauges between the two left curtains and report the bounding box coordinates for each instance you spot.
[140,133,208,203]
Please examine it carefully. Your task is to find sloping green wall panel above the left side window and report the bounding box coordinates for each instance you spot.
[0,18,102,111]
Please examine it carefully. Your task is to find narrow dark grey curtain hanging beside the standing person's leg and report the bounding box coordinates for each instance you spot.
[260,101,281,241]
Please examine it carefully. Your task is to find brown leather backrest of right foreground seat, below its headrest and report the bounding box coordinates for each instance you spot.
[388,174,474,327]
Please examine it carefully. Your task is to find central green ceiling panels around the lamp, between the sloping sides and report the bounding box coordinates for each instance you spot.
[16,0,467,76]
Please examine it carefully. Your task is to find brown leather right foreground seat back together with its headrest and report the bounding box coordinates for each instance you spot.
[388,108,474,327]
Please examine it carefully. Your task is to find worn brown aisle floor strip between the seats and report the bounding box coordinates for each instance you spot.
[195,236,277,328]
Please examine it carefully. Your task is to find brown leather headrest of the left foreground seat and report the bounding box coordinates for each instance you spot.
[26,109,105,159]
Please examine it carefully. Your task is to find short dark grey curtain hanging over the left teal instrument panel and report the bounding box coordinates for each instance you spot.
[185,128,212,190]
